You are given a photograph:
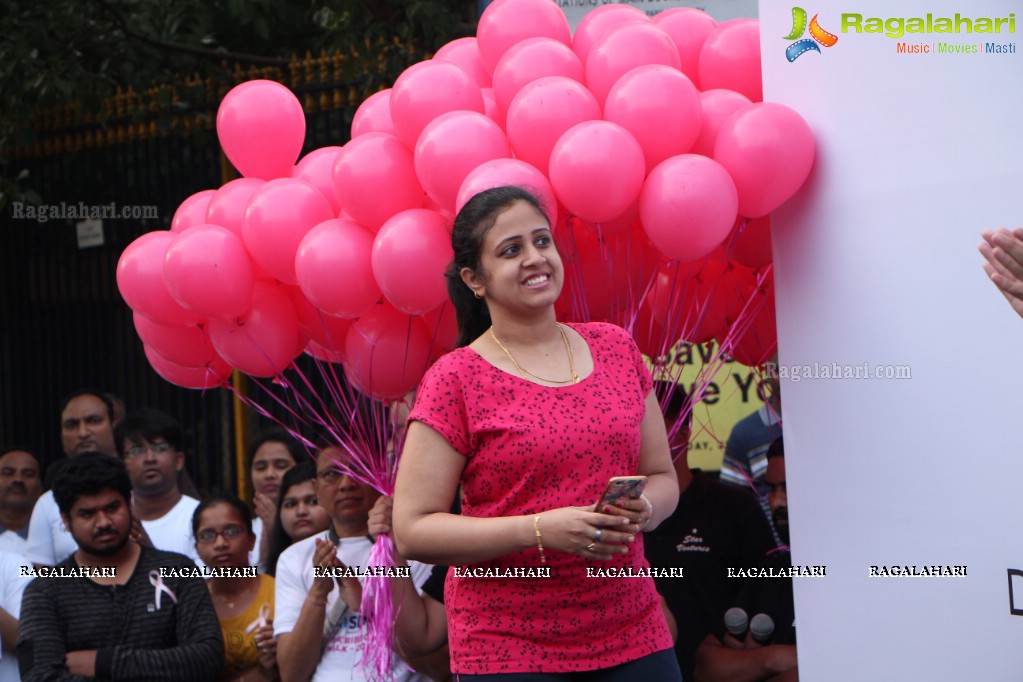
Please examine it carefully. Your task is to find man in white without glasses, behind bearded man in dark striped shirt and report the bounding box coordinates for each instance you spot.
[25,389,118,566]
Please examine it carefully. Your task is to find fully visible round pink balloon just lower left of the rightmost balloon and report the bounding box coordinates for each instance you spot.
[639,154,739,261]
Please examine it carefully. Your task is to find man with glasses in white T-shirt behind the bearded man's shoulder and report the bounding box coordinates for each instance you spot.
[114,408,204,567]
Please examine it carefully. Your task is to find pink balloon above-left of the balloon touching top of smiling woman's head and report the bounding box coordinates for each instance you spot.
[414,111,512,211]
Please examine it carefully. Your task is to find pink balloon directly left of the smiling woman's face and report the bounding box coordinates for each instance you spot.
[372,209,454,315]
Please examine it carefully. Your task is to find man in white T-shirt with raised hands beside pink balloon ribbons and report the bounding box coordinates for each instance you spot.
[273,449,432,682]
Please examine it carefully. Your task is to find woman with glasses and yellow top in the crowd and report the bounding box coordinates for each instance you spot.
[192,495,280,682]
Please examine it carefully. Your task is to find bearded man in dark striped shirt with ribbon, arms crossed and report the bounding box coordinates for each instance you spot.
[17,453,224,682]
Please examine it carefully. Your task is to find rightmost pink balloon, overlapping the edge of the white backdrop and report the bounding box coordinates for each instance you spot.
[714,102,814,218]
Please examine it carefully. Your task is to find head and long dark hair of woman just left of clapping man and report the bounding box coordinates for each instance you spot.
[264,459,330,576]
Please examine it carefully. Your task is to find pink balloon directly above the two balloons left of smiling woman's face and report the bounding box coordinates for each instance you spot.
[333,133,426,232]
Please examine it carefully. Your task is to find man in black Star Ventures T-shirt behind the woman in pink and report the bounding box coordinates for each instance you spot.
[643,381,774,680]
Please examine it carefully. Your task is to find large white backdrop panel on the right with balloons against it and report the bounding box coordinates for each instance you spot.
[760,0,1023,682]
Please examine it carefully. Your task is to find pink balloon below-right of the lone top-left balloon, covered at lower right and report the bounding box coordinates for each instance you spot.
[241,178,335,284]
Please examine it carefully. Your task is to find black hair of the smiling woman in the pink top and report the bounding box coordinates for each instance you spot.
[444,185,553,348]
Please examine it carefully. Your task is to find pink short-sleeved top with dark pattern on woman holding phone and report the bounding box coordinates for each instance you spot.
[409,323,671,675]
